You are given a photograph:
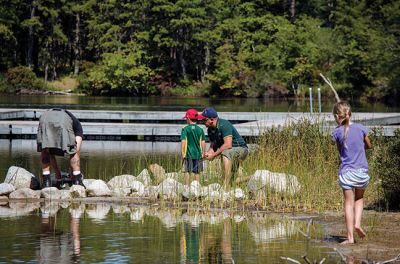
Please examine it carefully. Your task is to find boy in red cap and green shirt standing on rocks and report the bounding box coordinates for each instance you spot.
[181,109,206,185]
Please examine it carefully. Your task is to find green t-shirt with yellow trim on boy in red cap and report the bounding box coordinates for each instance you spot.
[181,124,206,159]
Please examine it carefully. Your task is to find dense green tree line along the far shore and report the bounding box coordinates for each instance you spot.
[0,0,400,98]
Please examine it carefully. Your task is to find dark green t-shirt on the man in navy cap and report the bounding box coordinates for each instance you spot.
[207,118,247,148]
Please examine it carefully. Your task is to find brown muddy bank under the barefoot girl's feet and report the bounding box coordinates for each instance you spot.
[318,211,400,263]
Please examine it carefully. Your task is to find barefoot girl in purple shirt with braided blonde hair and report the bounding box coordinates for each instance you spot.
[332,101,371,244]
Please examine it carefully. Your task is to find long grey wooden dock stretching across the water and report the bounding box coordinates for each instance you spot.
[0,109,400,142]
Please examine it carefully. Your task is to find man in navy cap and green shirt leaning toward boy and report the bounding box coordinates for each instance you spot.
[198,107,248,191]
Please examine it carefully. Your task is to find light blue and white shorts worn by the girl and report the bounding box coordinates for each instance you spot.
[338,169,369,190]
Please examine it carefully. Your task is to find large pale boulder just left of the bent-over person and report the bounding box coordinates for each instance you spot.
[4,166,40,190]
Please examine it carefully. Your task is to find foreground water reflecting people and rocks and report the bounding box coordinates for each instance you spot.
[0,204,339,263]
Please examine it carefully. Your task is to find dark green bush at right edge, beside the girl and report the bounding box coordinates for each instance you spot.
[377,129,400,208]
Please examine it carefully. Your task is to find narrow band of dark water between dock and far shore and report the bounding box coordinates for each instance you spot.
[0,95,400,112]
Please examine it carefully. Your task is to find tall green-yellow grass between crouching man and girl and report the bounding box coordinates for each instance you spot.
[239,119,383,211]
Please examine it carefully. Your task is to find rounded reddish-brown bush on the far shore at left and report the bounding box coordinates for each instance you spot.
[6,66,46,92]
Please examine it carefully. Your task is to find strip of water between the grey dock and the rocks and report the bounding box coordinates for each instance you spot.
[0,139,181,182]
